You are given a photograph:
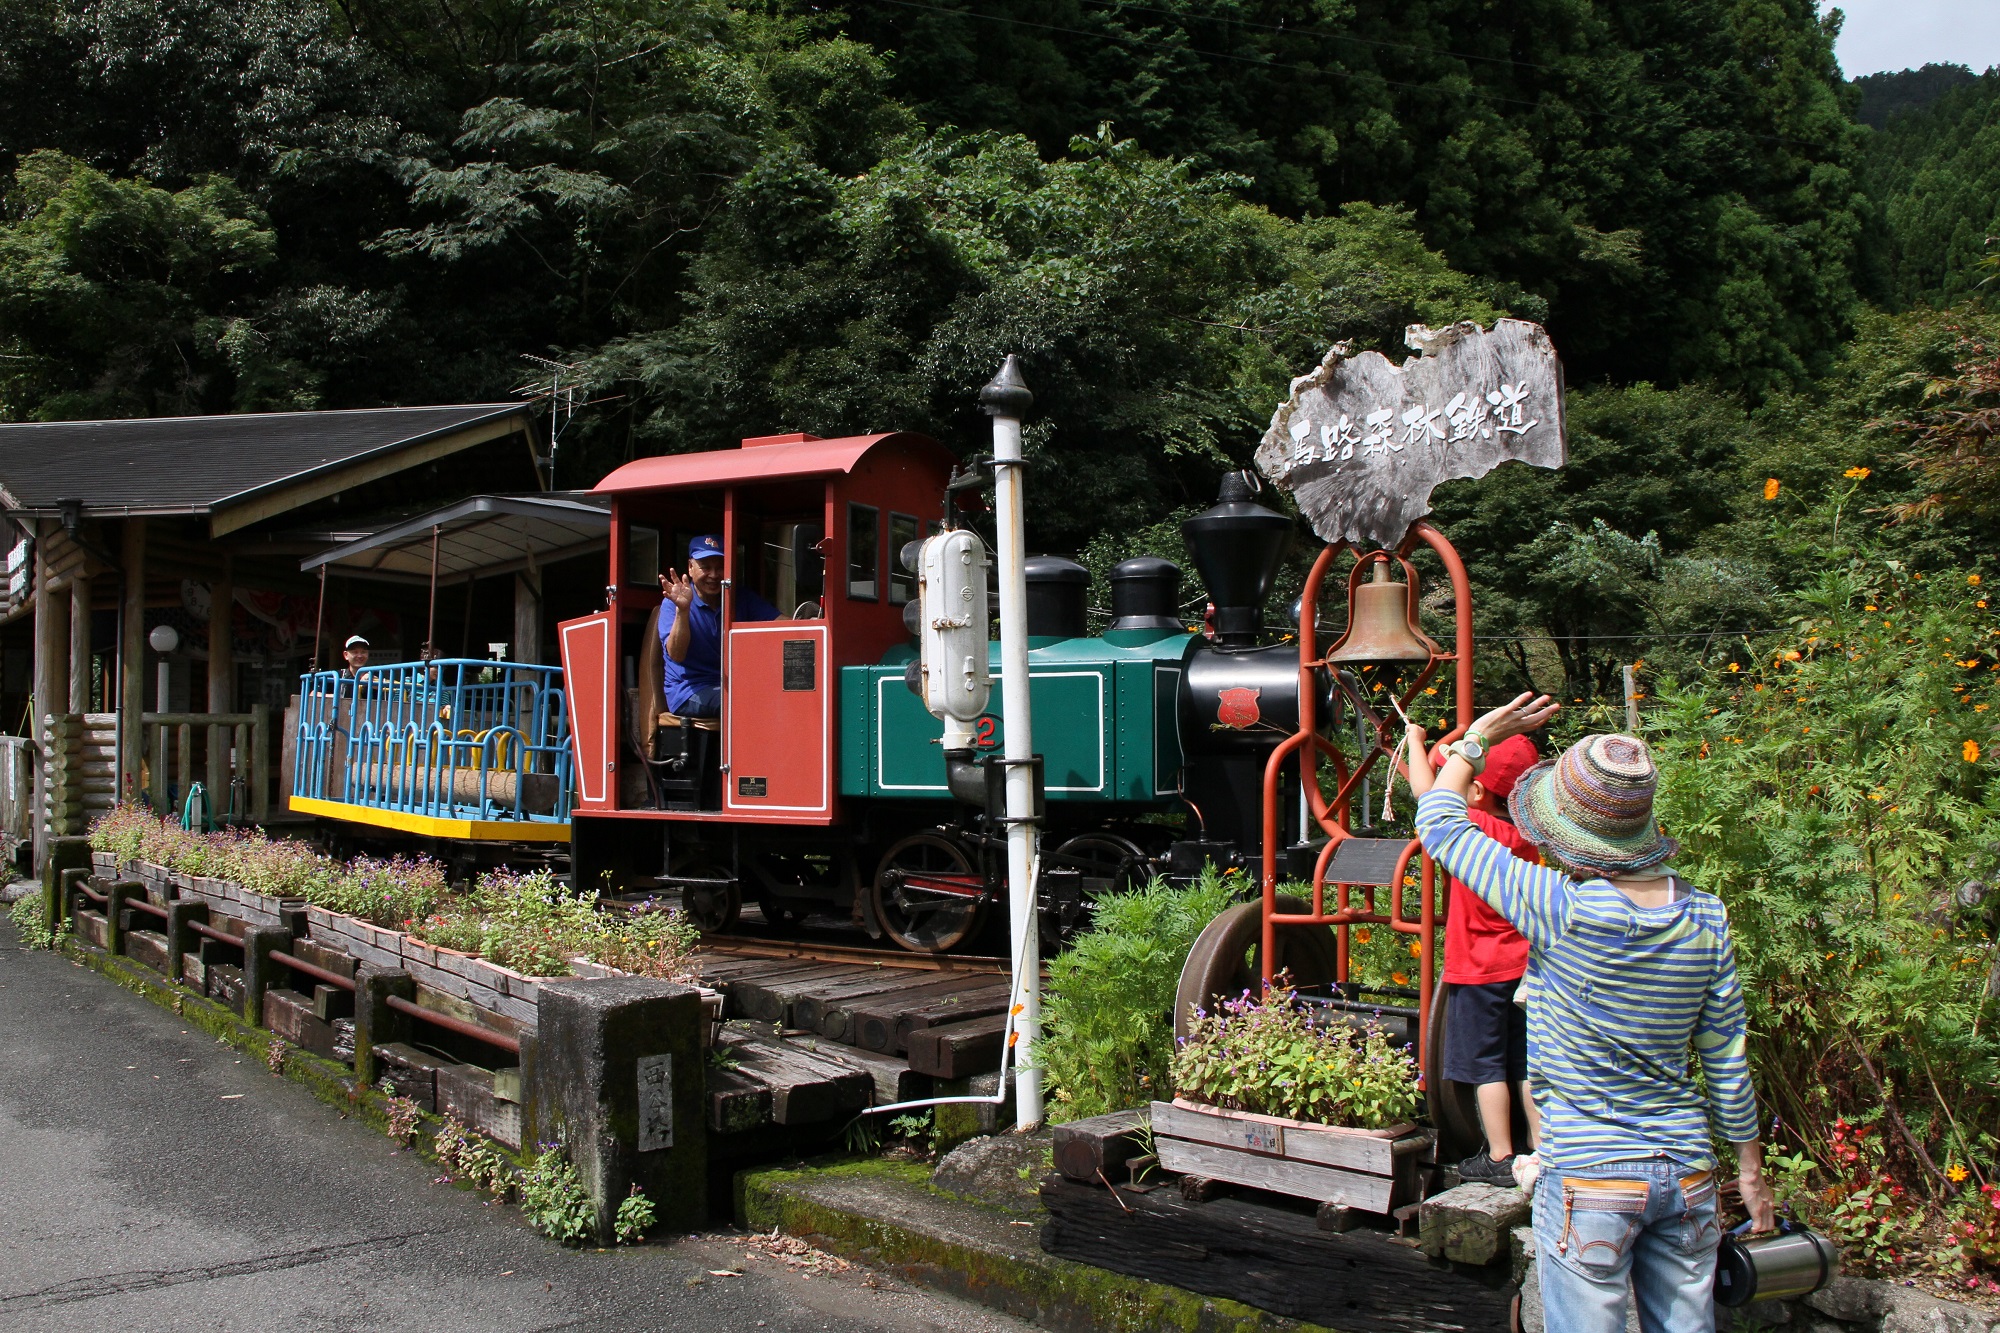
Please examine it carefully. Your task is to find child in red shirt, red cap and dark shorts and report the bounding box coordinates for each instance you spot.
[1430,737,1540,1187]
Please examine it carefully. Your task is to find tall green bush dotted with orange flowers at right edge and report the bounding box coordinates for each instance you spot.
[1648,550,2000,1197]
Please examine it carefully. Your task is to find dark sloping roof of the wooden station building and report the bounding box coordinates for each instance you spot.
[0,402,528,536]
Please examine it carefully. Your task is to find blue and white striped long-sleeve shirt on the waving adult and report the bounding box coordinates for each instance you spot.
[1416,789,1758,1169]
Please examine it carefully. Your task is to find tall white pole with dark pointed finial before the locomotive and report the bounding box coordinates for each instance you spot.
[980,354,1042,1129]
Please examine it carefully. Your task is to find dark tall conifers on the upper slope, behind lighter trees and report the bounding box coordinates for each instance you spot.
[832,0,1860,390]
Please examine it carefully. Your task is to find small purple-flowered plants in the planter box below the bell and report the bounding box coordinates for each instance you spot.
[1174,989,1422,1129]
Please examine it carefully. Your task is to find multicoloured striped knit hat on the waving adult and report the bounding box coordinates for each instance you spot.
[1506,735,1680,875]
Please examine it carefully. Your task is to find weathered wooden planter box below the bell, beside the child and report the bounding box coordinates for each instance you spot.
[1152,1097,1430,1213]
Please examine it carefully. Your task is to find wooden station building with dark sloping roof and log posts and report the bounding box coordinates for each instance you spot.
[0,402,542,868]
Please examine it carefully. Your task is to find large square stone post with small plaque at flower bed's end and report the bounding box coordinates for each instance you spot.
[522,977,708,1245]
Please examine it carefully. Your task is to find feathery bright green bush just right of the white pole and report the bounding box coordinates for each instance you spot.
[1034,871,1234,1121]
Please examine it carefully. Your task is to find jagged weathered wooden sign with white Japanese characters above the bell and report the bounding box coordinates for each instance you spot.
[1256,320,1568,548]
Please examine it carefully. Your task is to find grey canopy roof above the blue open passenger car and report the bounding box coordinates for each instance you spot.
[300,490,612,582]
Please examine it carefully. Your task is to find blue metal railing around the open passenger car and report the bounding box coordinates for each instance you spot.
[292,658,574,825]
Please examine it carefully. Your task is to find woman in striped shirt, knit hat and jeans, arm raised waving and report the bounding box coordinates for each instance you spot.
[1410,695,1774,1333]
